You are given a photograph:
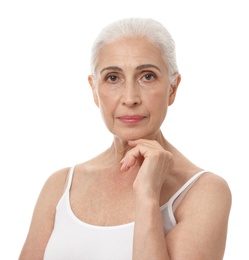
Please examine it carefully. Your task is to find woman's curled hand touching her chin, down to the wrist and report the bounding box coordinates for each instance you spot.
[121,139,174,199]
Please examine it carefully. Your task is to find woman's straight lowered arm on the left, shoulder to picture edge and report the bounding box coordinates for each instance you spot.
[19,169,68,260]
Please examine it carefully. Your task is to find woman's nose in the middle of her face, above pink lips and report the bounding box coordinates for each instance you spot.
[122,84,141,107]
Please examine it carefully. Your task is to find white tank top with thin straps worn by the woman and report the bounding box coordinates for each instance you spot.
[44,167,206,260]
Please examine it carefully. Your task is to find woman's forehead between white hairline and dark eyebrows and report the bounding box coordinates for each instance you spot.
[96,37,166,73]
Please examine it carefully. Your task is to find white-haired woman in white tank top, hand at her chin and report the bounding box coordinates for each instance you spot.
[19,19,231,260]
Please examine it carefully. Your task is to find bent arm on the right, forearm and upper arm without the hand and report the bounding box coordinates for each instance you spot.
[134,174,231,260]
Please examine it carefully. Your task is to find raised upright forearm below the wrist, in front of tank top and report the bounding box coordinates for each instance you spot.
[133,198,170,260]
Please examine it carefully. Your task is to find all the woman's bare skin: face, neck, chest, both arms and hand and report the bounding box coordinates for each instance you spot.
[19,38,231,260]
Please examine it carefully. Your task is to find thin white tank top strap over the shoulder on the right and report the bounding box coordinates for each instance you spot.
[169,170,207,212]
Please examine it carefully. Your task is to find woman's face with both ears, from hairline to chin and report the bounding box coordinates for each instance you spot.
[89,38,180,141]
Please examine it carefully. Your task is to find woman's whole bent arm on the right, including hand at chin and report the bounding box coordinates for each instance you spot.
[122,140,231,260]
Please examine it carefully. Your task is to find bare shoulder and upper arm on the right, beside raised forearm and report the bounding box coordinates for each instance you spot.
[167,173,232,260]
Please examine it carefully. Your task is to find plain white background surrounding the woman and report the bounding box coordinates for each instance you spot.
[0,0,249,260]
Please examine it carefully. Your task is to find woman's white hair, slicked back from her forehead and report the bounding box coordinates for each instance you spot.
[91,18,178,84]
